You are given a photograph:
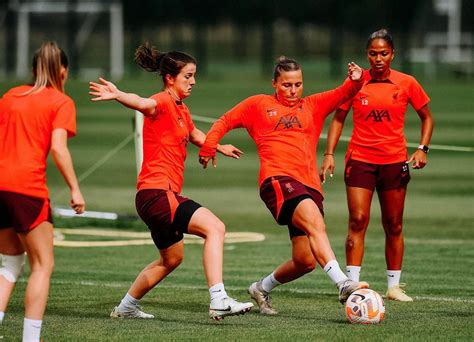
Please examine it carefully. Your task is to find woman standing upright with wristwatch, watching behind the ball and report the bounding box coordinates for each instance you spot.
[320,29,433,302]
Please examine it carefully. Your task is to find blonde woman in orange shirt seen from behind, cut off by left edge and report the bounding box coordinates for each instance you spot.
[0,42,84,341]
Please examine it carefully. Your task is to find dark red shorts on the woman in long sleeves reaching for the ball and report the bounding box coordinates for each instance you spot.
[260,176,324,238]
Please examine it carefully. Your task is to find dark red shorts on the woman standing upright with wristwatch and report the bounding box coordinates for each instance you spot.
[344,159,410,191]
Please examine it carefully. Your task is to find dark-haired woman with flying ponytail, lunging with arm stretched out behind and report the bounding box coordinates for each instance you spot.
[90,44,253,320]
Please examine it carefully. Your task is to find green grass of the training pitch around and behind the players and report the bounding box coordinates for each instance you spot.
[0,71,474,341]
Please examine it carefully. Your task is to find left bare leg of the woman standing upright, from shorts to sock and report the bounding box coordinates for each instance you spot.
[346,187,374,266]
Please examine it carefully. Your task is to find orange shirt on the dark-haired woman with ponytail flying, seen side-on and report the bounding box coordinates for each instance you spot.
[137,91,194,193]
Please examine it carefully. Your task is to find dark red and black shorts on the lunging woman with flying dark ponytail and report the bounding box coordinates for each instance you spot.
[135,189,201,249]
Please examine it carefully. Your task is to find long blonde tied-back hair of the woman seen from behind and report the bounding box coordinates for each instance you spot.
[24,42,68,95]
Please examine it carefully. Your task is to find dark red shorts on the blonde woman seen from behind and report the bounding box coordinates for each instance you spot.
[0,190,53,233]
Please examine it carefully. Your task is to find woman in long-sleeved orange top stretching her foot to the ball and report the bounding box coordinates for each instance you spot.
[199,57,368,315]
